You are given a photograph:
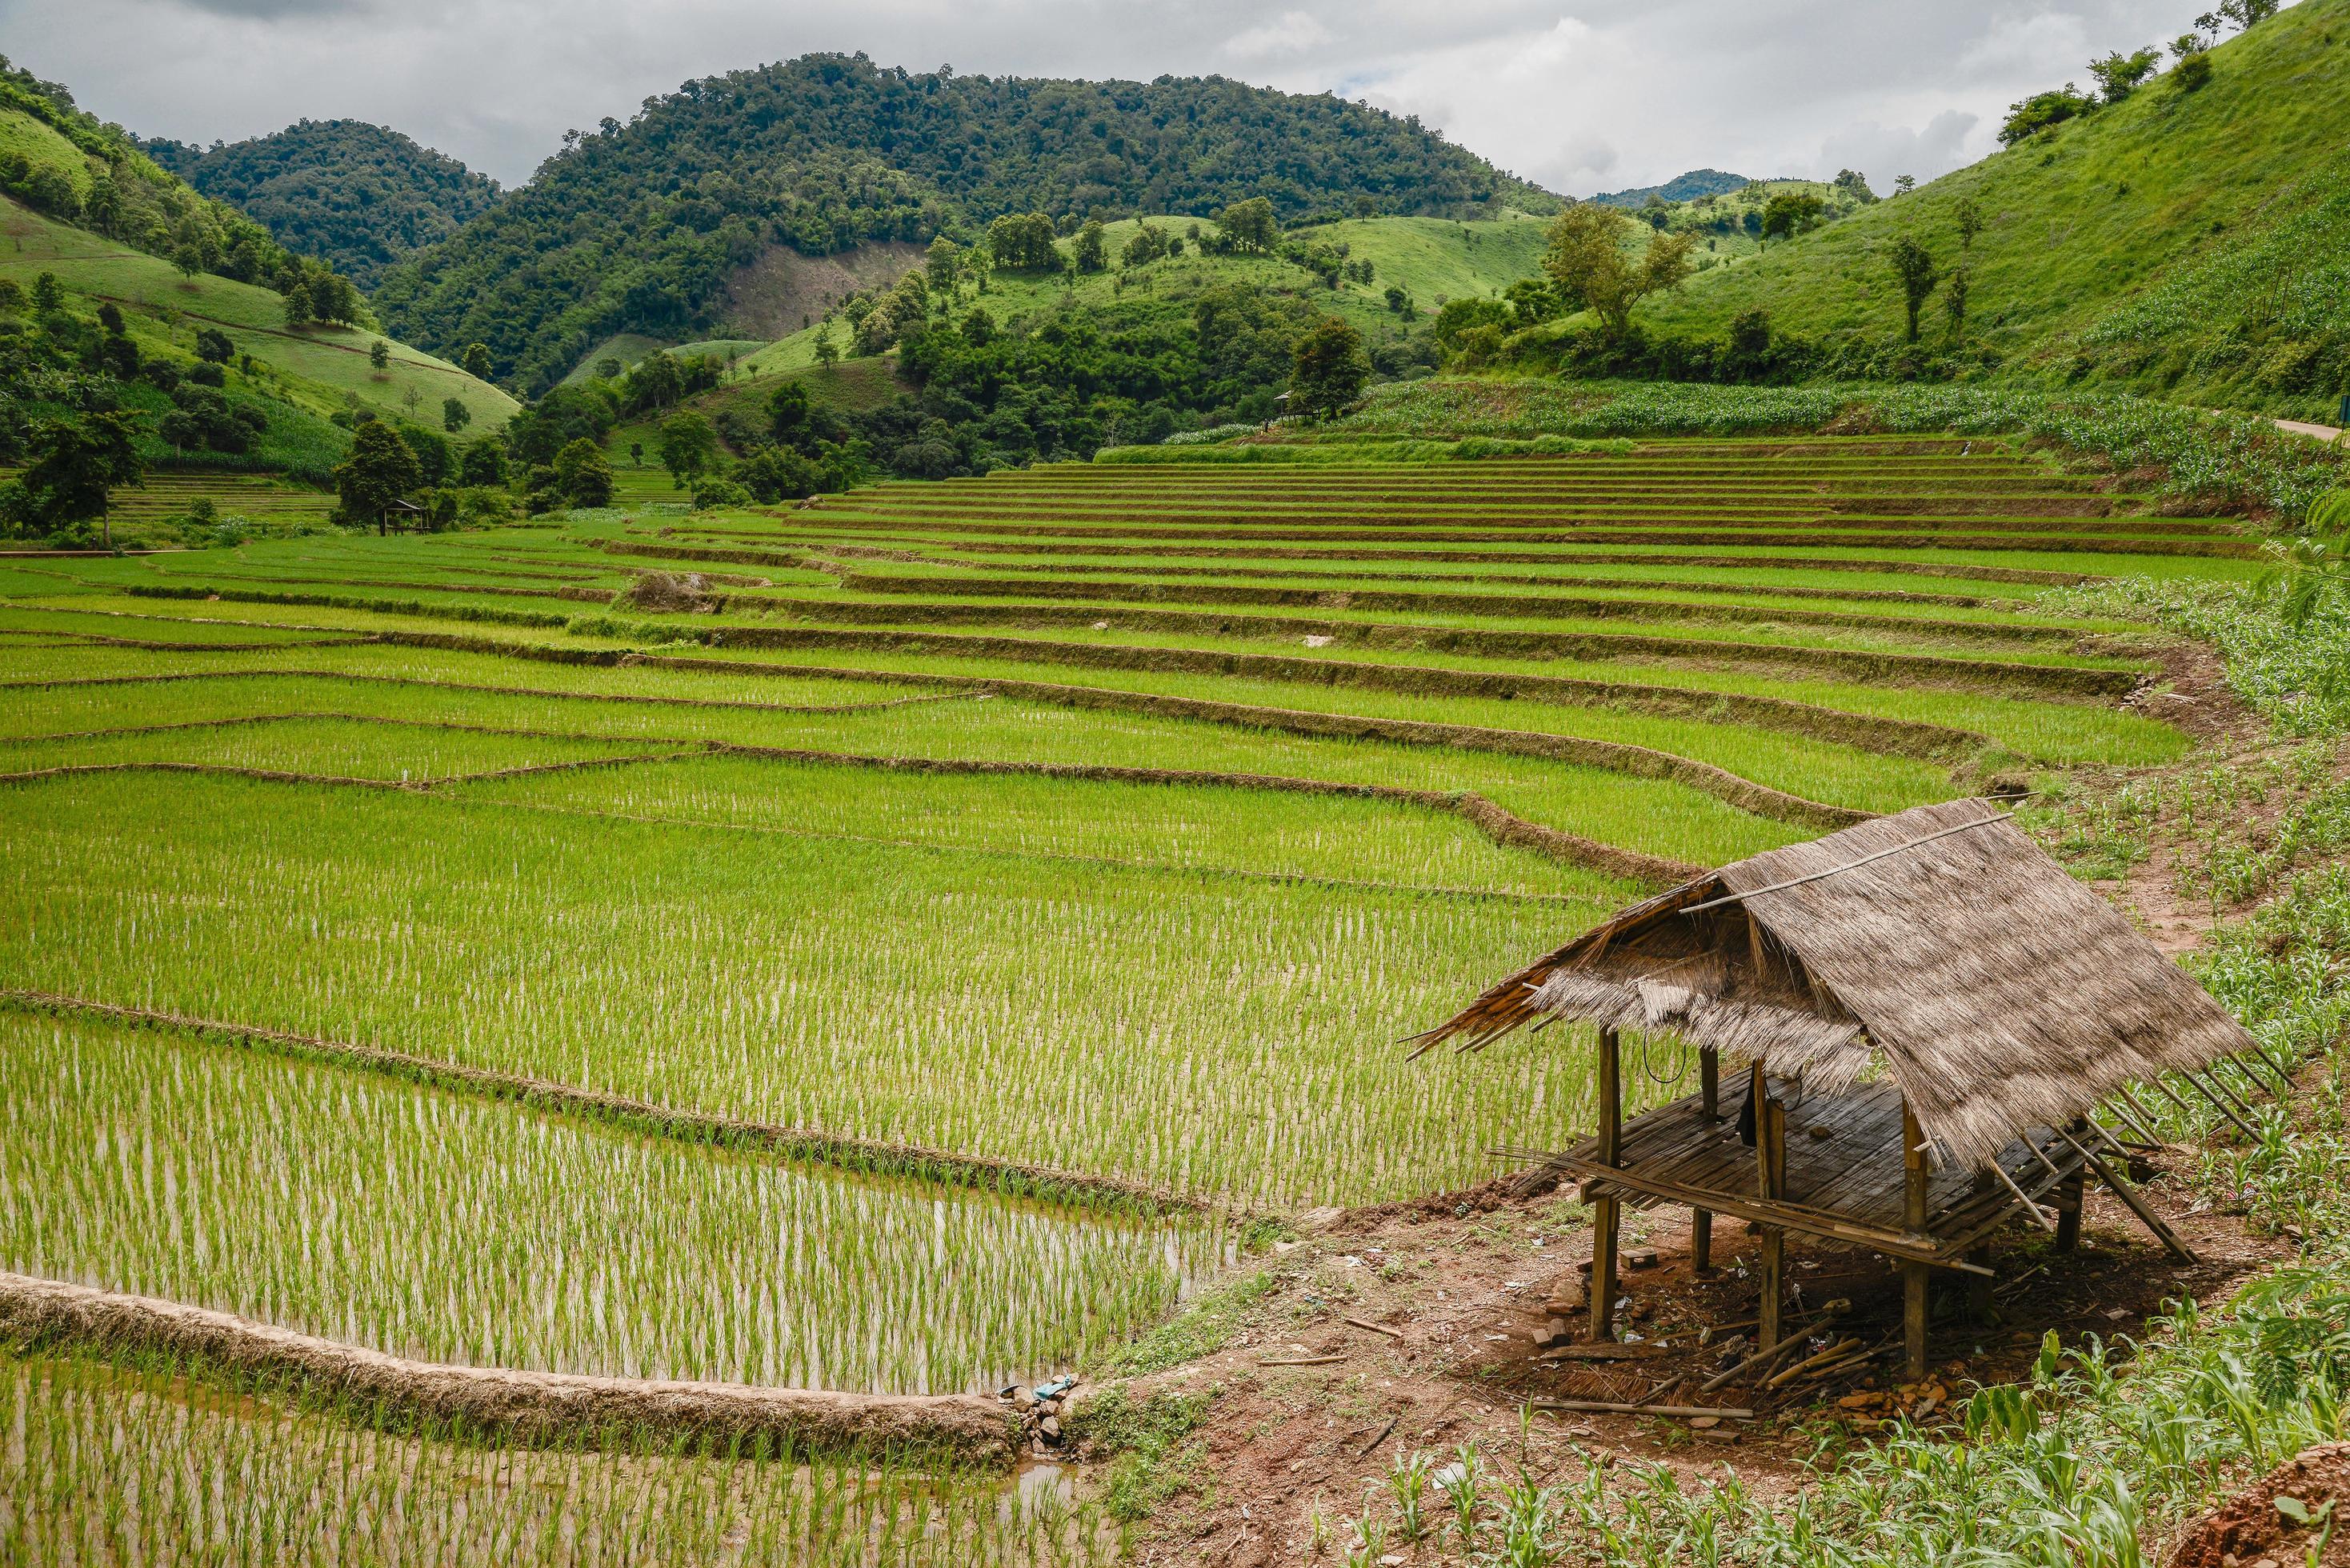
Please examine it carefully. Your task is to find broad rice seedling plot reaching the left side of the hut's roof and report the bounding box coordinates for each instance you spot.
[0,776,1668,1204]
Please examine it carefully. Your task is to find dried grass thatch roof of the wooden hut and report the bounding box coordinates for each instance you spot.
[1422,799,2252,1166]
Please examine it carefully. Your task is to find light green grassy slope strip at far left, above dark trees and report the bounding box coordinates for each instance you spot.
[0,198,519,433]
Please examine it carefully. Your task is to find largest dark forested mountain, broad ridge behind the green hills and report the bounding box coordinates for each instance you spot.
[376,54,1555,388]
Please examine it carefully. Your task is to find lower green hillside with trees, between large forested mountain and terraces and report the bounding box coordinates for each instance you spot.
[585,210,1544,484]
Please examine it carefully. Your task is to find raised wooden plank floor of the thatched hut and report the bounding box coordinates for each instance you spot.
[1572,1082,2080,1246]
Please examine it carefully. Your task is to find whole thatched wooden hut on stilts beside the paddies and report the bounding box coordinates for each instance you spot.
[1415,799,2282,1378]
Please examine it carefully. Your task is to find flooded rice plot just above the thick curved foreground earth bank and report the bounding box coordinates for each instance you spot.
[0,1014,1229,1394]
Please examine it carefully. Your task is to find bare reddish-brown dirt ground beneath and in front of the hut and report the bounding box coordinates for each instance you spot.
[1090,1150,2284,1566]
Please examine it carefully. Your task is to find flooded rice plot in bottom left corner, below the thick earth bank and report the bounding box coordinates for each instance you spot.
[0,1357,1119,1568]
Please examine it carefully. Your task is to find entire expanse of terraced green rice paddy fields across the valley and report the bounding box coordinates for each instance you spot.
[0,440,2258,1561]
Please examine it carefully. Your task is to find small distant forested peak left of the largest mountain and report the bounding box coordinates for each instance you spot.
[143,120,498,289]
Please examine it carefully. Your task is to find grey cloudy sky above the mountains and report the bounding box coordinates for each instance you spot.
[0,0,2209,195]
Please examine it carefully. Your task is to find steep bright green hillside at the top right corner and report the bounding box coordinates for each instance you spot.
[1643,0,2350,416]
